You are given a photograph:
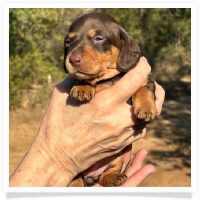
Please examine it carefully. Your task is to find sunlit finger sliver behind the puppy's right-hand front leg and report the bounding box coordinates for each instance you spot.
[155,82,165,115]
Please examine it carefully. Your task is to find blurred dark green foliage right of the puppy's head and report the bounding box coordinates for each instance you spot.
[101,8,191,66]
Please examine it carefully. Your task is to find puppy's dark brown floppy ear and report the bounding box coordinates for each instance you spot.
[117,27,141,72]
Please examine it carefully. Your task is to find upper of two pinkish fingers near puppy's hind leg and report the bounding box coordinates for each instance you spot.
[125,149,148,177]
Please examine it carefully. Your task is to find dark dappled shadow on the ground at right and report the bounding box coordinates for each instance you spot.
[148,80,191,170]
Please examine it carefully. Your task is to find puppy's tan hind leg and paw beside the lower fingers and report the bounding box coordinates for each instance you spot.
[99,155,127,187]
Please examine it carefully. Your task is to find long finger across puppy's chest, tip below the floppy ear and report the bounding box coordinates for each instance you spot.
[101,57,151,102]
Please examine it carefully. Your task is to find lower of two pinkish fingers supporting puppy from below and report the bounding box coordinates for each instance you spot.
[120,165,156,187]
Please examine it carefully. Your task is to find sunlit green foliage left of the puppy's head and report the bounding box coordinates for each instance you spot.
[9,8,89,109]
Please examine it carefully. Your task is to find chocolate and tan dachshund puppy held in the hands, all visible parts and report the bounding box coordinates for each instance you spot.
[64,13,157,187]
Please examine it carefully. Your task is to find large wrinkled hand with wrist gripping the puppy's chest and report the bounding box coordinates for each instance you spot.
[11,55,164,186]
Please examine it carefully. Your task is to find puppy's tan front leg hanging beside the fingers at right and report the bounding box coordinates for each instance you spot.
[132,74,158,121]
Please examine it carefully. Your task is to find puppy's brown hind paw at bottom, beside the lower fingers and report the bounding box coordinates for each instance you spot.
[99,172,127,187]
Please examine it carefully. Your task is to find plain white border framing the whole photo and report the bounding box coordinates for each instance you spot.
[1,0,199,193]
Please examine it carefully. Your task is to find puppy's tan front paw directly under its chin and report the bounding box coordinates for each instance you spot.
[70,85,95,101]
